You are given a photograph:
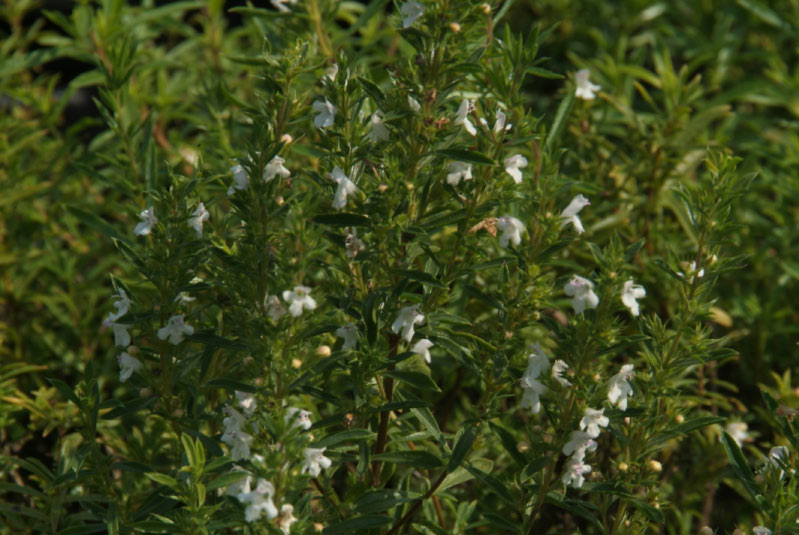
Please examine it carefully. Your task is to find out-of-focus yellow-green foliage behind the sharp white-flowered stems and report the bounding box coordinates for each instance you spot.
[0,0,799,532]
